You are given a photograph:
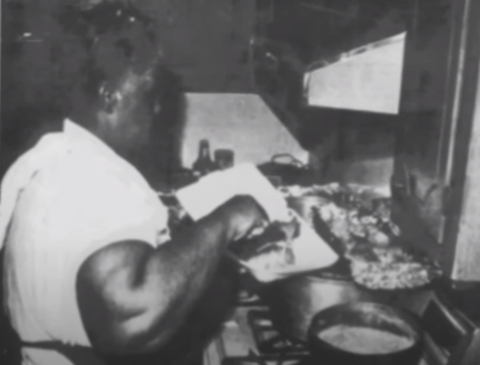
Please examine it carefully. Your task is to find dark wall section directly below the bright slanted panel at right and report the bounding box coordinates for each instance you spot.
[301,109,397,195]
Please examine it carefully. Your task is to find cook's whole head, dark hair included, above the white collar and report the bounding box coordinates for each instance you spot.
[64,2,188,182]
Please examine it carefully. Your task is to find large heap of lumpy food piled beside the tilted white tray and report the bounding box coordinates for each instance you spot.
[282,183,440,290]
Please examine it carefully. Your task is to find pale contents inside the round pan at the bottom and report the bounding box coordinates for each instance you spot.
[318,324,414,355]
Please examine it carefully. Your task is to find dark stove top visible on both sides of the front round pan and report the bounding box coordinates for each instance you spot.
[204,284,480,365]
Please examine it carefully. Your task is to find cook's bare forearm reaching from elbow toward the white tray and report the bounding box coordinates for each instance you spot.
[139,195,261,347]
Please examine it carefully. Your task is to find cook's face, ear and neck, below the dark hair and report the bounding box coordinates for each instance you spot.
[93,63,184,181]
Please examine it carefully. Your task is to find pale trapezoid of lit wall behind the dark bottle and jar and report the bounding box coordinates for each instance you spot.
[182,93,308,168]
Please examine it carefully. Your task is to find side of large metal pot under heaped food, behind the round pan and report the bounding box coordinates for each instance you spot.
[261,260,379,342]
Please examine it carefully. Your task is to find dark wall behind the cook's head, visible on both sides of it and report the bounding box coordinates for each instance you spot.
[1,0,256,174]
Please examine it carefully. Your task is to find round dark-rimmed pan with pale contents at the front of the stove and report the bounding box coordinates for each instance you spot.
[308,302,423,365]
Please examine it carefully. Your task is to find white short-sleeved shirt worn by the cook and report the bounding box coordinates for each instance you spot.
[0,120,169,365]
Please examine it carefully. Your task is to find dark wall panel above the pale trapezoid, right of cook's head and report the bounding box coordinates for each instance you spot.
[161,0,256,92]
